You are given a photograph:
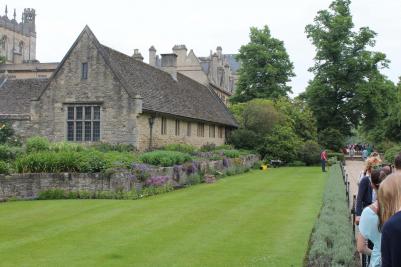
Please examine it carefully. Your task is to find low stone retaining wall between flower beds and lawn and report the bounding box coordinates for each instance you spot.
[0,155,259,200]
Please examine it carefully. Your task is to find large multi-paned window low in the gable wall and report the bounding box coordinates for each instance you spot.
[67,105,100,142]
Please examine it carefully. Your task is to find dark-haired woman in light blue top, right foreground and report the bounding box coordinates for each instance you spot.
[357,170,387,267]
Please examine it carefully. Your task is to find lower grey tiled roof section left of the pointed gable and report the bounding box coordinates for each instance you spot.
[0,79,48,116]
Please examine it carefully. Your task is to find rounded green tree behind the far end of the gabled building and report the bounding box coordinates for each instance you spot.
[230,26,295,103]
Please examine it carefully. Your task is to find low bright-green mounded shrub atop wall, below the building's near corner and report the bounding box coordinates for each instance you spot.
[139,150,192,167]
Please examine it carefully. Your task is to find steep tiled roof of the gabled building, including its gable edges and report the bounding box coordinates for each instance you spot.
[38,26,234,127]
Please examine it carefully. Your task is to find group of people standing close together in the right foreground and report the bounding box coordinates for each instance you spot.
[355,152,401,267]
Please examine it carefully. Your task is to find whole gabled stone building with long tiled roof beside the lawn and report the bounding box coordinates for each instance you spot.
[0,27,237,150]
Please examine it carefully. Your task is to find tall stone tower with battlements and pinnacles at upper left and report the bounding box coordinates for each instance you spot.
[0,6,36,64]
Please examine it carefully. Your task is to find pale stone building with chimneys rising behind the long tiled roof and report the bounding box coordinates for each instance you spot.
[148,45,239,105]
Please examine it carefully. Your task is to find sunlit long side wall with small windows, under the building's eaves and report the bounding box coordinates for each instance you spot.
[137,114,226,151]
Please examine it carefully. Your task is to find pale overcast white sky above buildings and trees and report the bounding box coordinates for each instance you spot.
[5,0,401,95]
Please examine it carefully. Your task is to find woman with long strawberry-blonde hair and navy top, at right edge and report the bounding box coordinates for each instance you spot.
[378,173,401,267]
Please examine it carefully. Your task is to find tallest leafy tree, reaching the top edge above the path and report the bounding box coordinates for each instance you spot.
[305,0,389,136]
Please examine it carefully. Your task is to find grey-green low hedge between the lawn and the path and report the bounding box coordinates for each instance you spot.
[305,164,358,266]
